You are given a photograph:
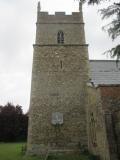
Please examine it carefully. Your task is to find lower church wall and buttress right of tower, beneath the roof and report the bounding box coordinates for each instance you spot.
[87,85,120,160]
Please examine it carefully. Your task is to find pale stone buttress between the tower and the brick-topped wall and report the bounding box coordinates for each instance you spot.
[87,87,110,160]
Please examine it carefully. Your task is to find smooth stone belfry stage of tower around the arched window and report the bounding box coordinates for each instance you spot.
[36,23,85,45]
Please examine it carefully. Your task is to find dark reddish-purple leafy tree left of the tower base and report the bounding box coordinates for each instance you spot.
[0,103,28,142]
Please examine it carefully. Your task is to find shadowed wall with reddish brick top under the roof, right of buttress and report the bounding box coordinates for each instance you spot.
[100,85,120,159]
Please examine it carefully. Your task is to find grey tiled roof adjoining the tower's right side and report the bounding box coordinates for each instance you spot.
[89,60,120,85]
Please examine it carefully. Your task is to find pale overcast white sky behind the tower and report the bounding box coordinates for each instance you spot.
[0,0,119,112]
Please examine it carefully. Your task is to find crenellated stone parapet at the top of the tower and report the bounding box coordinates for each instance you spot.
[37,12,83,23]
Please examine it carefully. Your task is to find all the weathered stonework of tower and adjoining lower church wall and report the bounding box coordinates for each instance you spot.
[27,2,120,160]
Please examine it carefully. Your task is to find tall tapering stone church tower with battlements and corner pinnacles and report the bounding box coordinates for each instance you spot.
[27,3,88,154]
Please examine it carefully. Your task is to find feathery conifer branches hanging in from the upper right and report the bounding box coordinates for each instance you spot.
[81,0,120,61]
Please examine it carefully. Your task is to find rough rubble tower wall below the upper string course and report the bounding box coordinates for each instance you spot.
[28,45,88,154]
